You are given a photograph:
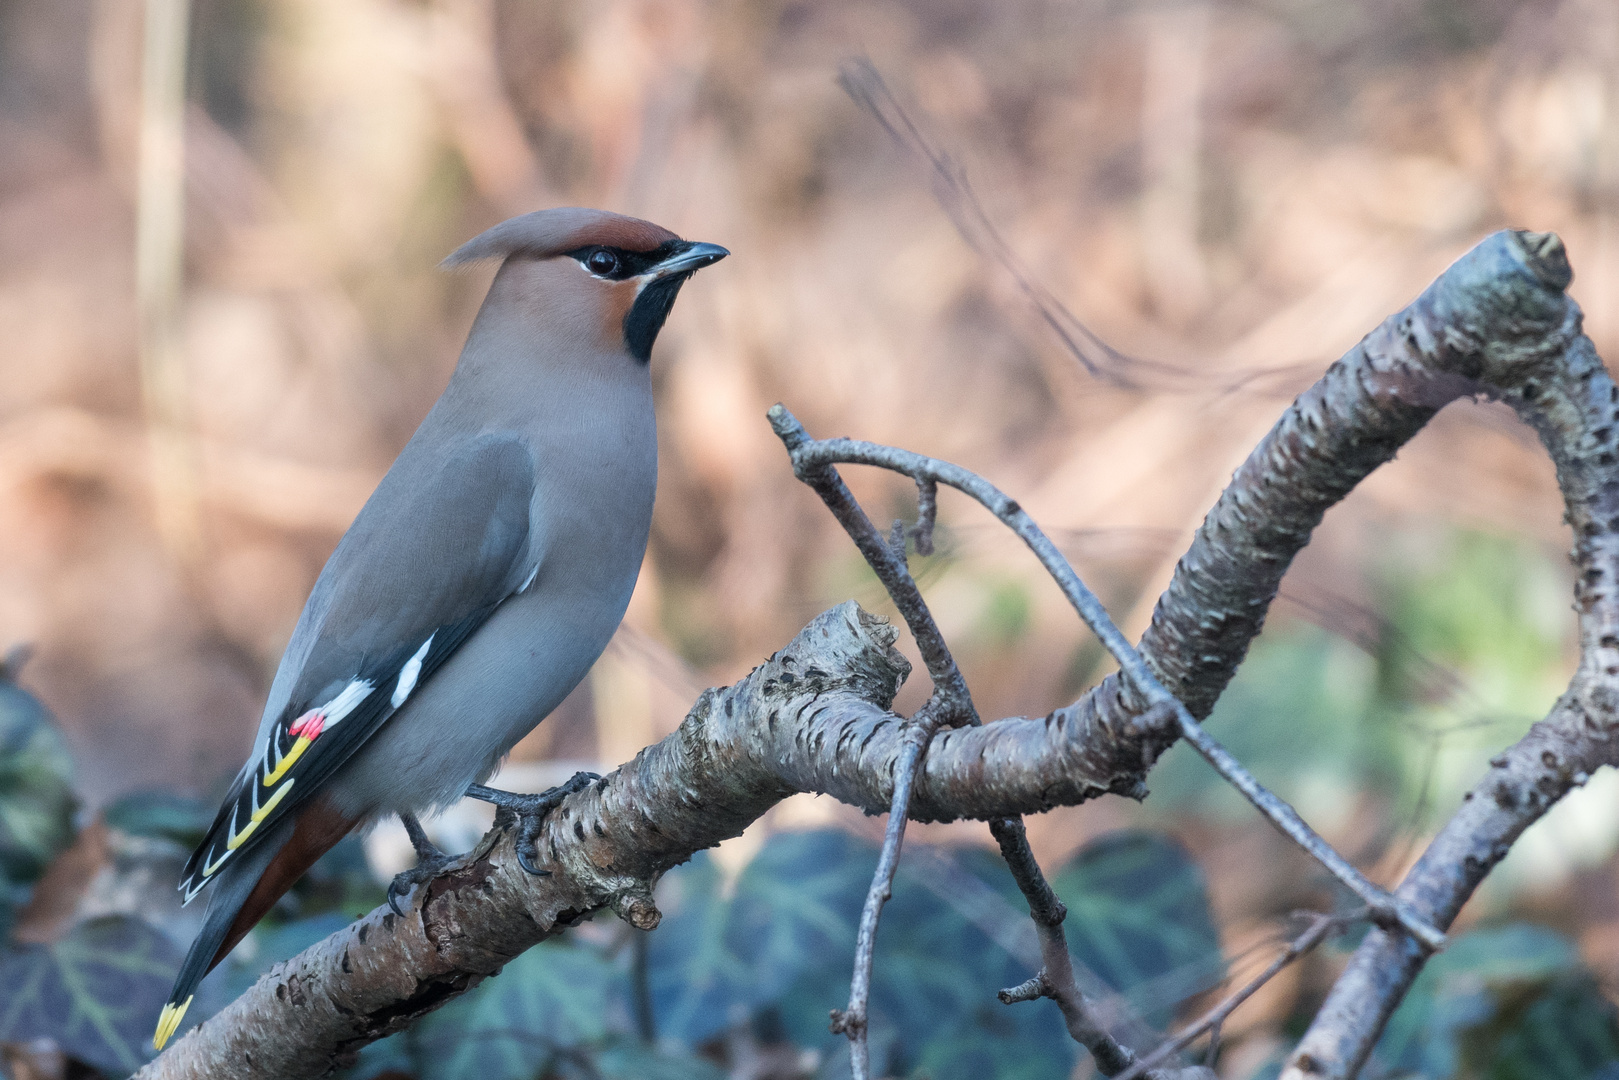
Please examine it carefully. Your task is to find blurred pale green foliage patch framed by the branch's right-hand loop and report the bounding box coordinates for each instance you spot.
[1149,531,1570,831]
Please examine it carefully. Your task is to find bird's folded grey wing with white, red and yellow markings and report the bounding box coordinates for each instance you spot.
[180,436,536,900]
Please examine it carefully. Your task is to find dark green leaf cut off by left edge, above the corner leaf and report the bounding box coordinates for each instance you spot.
[0,667,74,931]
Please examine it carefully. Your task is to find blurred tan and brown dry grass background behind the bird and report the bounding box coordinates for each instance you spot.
[0,0,1619,1062]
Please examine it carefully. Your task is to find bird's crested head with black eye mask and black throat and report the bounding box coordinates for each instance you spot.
[444,207,730,364]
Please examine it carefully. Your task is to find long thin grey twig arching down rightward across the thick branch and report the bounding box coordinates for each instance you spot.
[769,405,1444,950]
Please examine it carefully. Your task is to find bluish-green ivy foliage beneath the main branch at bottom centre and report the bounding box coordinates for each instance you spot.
[344,831,1219,1080]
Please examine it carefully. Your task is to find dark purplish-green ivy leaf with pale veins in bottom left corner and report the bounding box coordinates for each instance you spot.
[0,915,180,1075]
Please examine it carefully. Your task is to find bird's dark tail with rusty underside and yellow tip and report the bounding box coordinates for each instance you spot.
[152,798,356,1049]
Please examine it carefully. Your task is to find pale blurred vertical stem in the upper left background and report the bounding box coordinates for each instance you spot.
[134,0,201,563]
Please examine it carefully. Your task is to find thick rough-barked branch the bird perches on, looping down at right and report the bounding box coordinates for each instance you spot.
[139,233,1619,1080]
